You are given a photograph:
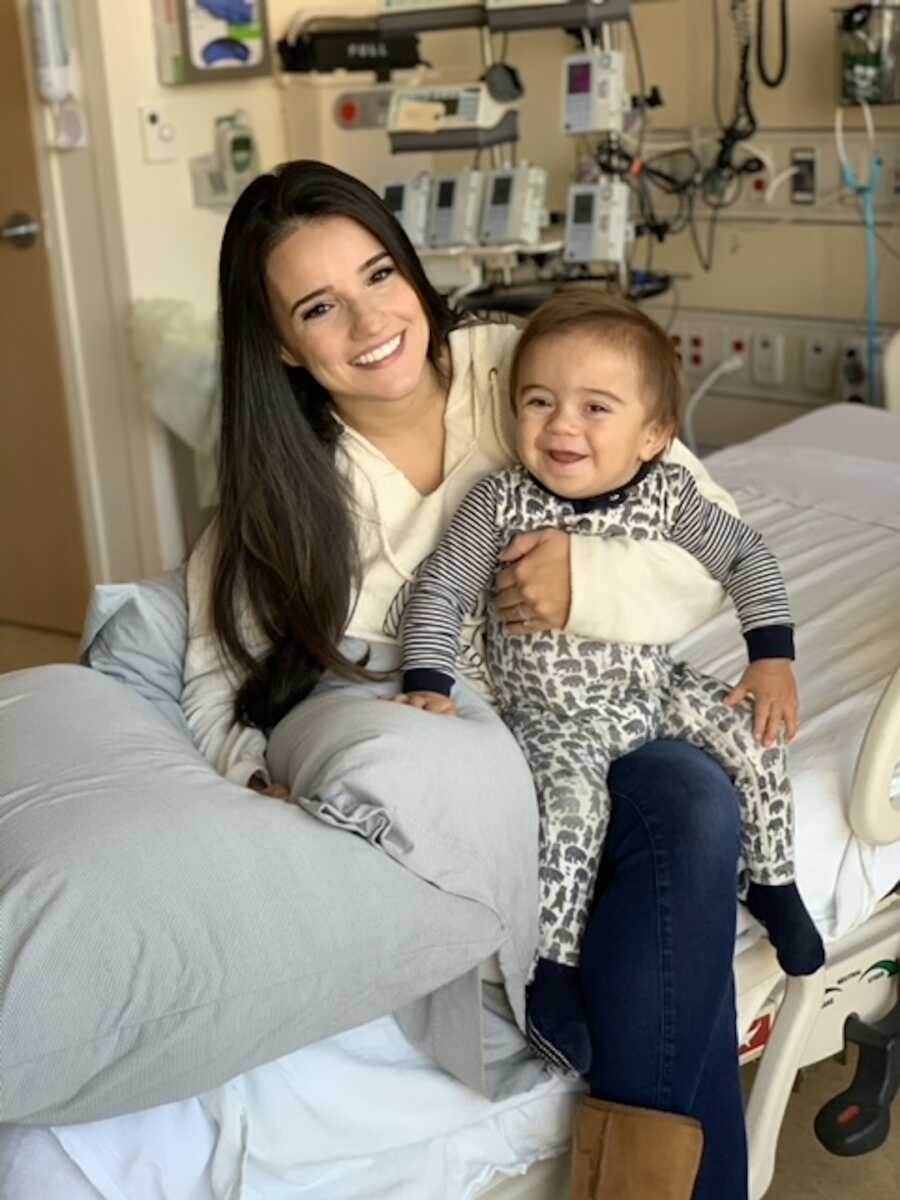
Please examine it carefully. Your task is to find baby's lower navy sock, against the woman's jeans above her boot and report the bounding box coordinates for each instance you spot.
[526,959,590,1075]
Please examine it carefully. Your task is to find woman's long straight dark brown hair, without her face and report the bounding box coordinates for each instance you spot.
[211,160,456,731]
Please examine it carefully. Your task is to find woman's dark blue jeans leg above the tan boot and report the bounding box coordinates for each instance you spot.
[581,740,748,1200]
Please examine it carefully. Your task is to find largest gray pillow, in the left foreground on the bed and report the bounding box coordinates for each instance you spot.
[0,667,508,1124]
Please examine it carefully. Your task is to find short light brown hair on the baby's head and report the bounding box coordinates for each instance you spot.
[510,286,685,436]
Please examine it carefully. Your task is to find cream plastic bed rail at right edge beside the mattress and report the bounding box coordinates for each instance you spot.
[847,667,900,846]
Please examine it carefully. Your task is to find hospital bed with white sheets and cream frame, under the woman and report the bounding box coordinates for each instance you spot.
[0,406,900,1200]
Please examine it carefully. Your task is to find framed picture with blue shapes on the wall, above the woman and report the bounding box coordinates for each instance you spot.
[154,0,271,84]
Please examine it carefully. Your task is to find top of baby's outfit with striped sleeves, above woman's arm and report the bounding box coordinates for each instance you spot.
[402,462,793,695]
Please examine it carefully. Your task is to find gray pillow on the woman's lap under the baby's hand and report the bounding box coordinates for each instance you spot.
[266,657,539,1088]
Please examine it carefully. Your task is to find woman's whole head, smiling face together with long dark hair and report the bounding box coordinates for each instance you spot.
[197,162,454,739]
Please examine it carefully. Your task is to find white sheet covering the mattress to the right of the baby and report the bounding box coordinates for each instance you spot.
[674,406,900,940]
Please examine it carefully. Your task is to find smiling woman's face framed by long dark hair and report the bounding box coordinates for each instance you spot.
[266,216,430,415]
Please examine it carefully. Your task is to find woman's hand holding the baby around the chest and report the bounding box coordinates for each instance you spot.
[496,529,572,634]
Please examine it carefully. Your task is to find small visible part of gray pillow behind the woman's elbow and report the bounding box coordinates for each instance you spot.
[82,566,187,733]
